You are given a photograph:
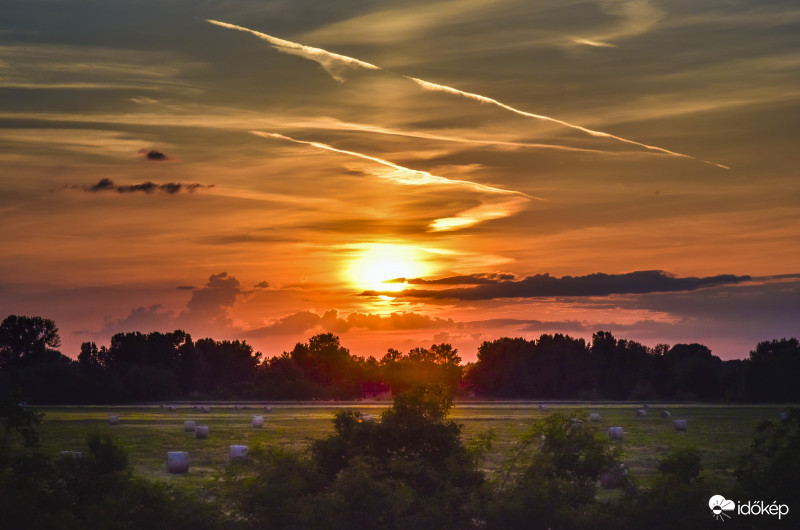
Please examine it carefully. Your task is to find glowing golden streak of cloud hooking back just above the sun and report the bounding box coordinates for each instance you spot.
[250,131,543,232]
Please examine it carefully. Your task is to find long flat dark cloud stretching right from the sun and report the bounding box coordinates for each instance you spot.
[362,271,751,300]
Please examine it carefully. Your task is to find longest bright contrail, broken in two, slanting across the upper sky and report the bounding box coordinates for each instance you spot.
[206,19,730,169]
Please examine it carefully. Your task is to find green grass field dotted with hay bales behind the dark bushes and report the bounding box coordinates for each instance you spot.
[18,401,787,490]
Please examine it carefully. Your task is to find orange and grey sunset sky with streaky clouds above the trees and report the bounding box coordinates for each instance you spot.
[0,0,800,361]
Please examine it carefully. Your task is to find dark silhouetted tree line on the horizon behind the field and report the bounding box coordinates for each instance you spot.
[0,315,800,404]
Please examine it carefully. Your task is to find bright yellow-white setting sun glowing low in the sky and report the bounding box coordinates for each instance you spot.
[348,243,430,294]
